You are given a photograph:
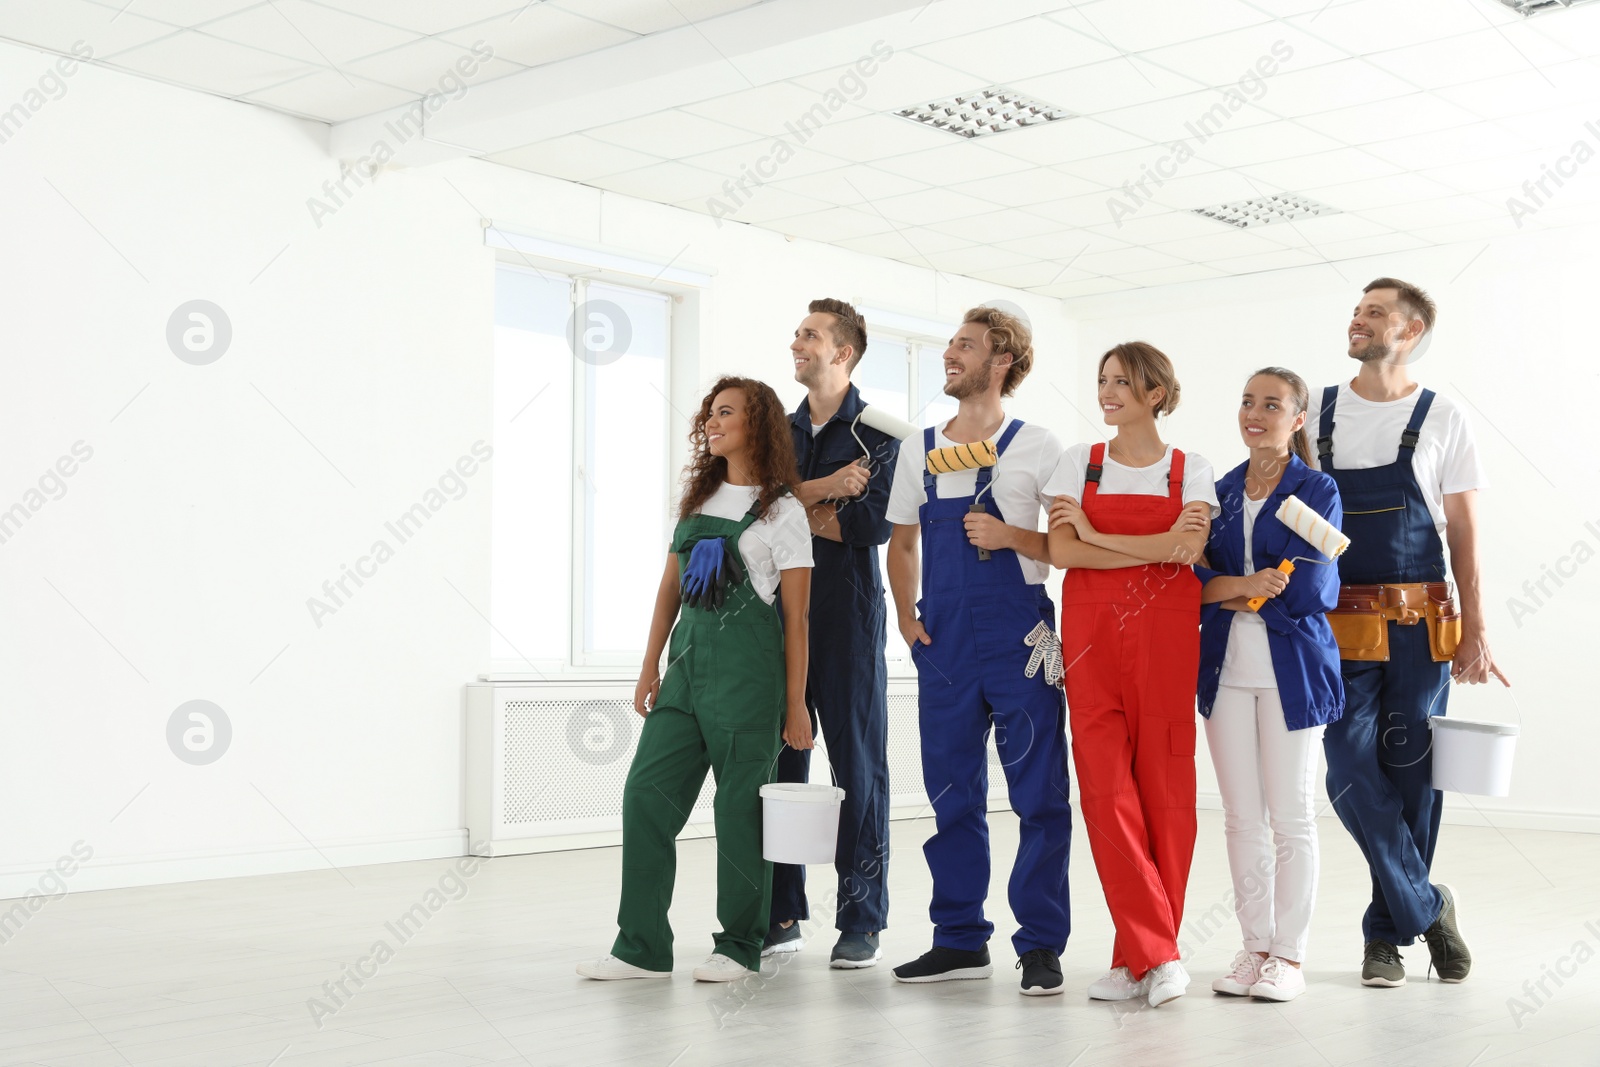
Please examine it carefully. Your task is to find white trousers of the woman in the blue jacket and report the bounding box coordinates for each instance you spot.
[1205,685,1326,963]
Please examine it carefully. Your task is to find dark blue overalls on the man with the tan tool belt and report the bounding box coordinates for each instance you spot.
[1317,386,1450,945]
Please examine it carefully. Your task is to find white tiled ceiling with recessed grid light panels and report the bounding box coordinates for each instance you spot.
[0,0,1600,298]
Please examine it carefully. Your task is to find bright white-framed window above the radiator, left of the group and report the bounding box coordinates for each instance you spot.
[490,264,672,672]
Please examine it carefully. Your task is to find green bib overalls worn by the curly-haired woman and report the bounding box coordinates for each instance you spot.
[611,506,786,971]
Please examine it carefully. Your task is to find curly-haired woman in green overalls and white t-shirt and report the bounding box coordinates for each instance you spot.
[578,378,811,982]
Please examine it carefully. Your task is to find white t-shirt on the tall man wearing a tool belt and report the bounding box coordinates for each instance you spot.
[1306,382,1490,537]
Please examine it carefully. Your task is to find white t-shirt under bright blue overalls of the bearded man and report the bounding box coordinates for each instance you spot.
[886,419,1061,585]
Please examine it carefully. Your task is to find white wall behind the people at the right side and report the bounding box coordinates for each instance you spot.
[1067,227,1600,830]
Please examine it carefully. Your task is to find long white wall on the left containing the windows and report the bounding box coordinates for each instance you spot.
[0,37,1080,897]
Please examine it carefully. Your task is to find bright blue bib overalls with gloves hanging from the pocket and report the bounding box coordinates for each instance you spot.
[912,421,1072,955]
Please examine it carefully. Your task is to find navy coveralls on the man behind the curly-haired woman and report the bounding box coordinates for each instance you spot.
[771,386,899,934]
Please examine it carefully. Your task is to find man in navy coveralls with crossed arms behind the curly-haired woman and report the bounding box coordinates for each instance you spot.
[762,299,899,968]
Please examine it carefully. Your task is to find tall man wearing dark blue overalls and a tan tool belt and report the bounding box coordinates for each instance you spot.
[1307,278,1510,985]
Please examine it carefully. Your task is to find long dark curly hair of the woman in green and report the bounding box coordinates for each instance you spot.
[678,376,800,518]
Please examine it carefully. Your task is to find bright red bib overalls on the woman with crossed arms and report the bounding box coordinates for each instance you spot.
[1061,443,1200,979]
